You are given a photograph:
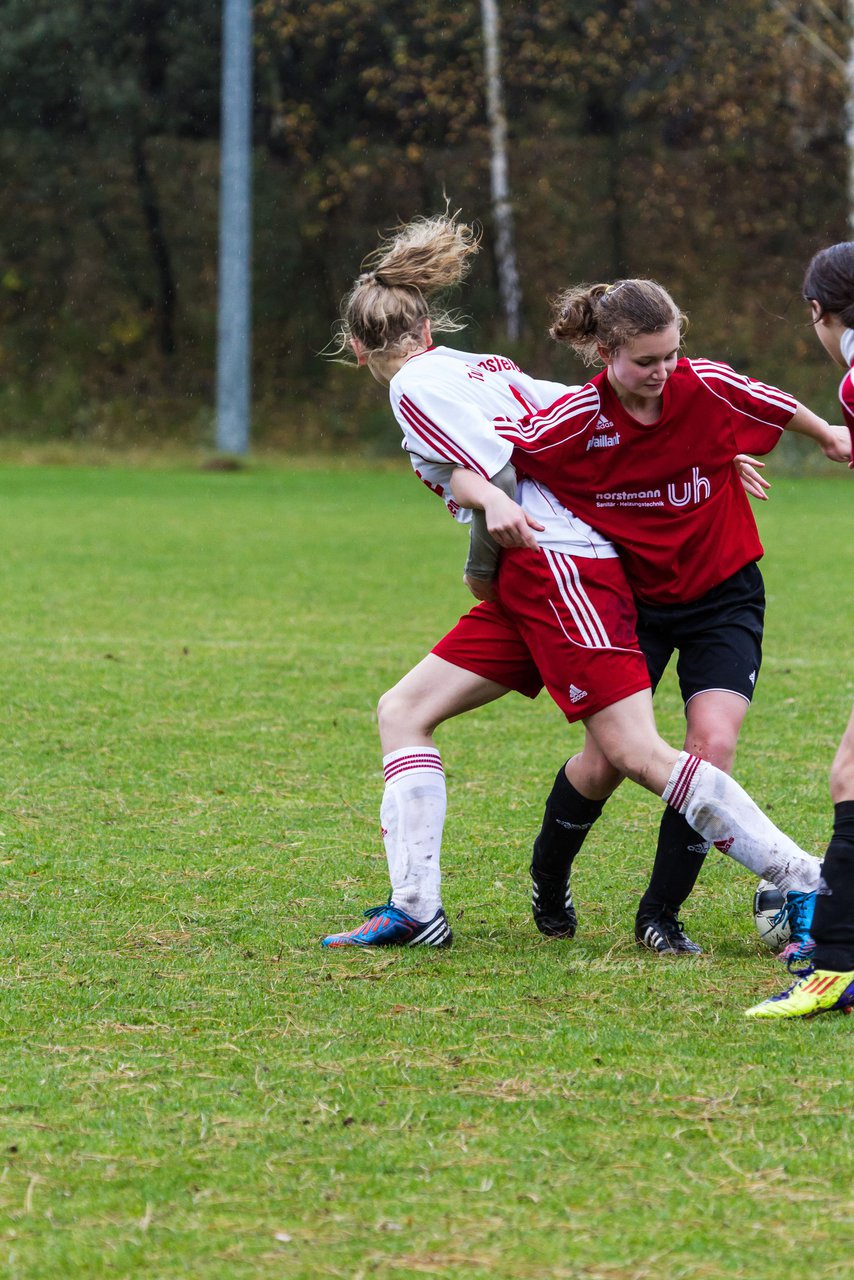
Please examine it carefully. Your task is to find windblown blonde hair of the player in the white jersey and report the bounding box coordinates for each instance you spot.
[330,211,480,360]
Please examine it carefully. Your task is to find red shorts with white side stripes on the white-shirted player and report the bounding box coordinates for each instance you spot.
[433,549,649,721]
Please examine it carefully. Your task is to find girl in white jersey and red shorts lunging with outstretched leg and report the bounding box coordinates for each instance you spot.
[318,209,819,947]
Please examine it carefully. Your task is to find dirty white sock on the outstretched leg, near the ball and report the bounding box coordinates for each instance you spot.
[662,751,821,893]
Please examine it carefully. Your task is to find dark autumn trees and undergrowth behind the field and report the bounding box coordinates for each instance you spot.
[0,0,848,443]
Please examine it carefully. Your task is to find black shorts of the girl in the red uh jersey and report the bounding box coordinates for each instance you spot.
[638,562,766,705]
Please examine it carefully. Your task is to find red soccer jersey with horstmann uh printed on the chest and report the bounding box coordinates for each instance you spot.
[498,360,796,604]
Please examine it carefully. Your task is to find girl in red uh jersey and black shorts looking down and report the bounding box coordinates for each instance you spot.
[473,279,850,959]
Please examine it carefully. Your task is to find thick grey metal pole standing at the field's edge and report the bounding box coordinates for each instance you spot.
[216,0,252,453]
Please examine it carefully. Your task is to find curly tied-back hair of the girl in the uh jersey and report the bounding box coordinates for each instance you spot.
[549,280,688,365]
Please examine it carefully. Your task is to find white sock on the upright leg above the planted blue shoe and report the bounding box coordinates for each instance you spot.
[379,746,447,920]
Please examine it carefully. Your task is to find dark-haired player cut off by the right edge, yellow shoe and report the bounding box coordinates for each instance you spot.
[746,242,854,1018]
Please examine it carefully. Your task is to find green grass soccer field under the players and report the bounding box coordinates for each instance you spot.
[0,463,854,1280]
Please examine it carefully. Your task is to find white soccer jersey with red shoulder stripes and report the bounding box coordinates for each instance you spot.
[389,347,617,558]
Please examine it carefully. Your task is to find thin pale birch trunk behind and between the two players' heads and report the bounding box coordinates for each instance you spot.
[480,0,524,342]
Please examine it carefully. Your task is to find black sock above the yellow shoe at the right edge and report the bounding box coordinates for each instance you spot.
[810,800,854,973]
